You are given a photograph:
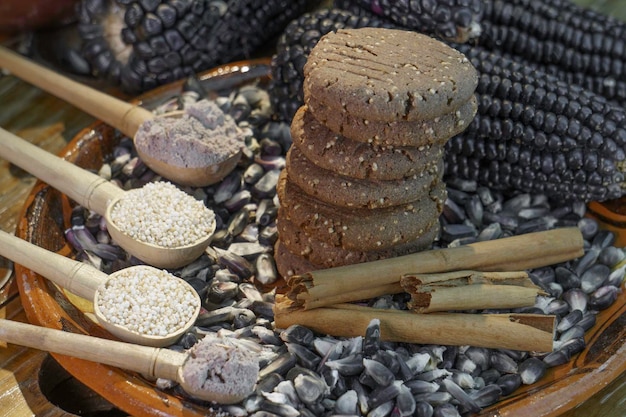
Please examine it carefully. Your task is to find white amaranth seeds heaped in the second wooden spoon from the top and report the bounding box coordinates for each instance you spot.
[111,181,215,248]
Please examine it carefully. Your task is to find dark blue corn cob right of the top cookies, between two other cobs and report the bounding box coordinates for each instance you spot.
[457,45,626,159]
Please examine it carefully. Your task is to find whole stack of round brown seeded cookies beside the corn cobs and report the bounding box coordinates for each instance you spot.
[275,28,477,276]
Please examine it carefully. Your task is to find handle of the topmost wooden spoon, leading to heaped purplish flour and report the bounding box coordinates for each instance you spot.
[0,47,153,138]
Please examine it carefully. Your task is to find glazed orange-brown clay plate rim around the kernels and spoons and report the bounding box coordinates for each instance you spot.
[15,61,626,417]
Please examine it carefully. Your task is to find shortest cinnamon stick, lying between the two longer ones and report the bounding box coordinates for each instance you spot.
[400,271,546,313]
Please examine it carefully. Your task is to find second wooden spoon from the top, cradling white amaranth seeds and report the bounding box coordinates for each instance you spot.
[0,128,215,268]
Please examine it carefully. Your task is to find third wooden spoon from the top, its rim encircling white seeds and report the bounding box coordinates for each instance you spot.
[0,231,201,346]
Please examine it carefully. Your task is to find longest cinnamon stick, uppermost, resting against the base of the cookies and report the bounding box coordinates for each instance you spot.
[287,227,584,309]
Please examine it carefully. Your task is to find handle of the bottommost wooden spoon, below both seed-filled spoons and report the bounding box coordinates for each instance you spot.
[0,319,187,381]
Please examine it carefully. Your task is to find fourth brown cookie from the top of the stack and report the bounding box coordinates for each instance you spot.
[286,146,443,209]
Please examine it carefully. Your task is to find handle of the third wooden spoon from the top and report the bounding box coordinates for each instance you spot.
[0,230,109,301]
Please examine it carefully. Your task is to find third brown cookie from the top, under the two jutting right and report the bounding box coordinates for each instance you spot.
[291,106,443,181]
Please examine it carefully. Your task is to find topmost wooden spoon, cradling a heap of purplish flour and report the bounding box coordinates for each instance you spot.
[0,47,241,187]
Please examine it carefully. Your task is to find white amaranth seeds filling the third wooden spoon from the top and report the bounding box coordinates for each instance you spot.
[97,265,199,336]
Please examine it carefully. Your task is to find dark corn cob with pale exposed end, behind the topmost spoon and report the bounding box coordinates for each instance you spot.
[77,0,319,93]
